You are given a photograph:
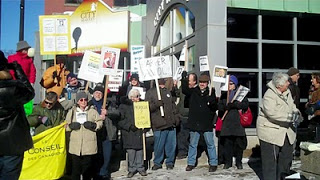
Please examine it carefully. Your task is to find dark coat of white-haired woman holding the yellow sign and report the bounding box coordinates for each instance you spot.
[118,99,142,150]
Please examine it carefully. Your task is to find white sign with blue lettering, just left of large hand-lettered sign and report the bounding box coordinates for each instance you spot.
[130,45,145,73]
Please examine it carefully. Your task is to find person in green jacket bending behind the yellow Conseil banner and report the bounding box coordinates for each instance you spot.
[28,92,65,135]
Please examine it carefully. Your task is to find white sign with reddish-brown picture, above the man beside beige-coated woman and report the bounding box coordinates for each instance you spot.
[100,47,120,75]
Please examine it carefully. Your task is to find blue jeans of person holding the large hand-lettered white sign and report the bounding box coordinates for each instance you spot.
[153,128,177,166]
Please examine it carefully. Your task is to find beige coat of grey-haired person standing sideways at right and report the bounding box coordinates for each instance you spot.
[257,82,299,146]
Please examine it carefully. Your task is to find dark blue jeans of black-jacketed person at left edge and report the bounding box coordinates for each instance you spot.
[0,155,23,180]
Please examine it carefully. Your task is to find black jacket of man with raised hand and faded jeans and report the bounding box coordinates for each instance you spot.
[182,79,217,132]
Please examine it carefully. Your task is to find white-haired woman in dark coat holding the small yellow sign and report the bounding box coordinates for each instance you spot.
[118,89,147,178]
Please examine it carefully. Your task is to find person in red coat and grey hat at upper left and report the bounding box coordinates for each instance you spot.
[8,41,36,86]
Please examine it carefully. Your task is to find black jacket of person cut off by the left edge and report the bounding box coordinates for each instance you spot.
[0,66,34,156]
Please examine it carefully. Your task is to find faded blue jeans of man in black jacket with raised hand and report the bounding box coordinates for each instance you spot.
[188,131,218,166]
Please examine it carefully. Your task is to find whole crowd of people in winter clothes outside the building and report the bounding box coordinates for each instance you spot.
[0,41,320,180]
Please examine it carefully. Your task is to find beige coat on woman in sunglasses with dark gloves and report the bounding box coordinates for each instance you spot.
[66,107,103,156]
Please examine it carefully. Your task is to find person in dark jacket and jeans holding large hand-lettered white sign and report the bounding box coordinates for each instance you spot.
[146,79,179,170]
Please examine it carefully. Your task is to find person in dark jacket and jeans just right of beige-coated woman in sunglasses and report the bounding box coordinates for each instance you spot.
[88,84,120,180]
